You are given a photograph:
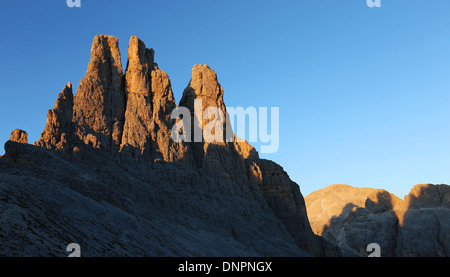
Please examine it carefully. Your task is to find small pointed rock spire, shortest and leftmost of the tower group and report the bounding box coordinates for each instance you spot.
[34,83,73,151]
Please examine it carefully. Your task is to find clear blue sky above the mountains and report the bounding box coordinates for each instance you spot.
[0,0,450,198]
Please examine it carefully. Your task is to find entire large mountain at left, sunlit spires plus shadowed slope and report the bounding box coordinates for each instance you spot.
[0,35,341,256]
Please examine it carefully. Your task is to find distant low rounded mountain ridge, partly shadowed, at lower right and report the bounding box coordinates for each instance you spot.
[305,184,450,257]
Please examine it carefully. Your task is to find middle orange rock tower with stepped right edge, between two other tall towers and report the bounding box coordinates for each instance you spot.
[121,37,190,163]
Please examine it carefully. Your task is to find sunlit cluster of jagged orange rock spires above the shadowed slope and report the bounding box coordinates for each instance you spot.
[35,35,257,165]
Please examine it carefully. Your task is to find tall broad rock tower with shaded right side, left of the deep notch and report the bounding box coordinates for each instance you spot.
[73,35,125,151]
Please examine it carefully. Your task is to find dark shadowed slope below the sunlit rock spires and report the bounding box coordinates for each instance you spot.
[0,141,311,257]
